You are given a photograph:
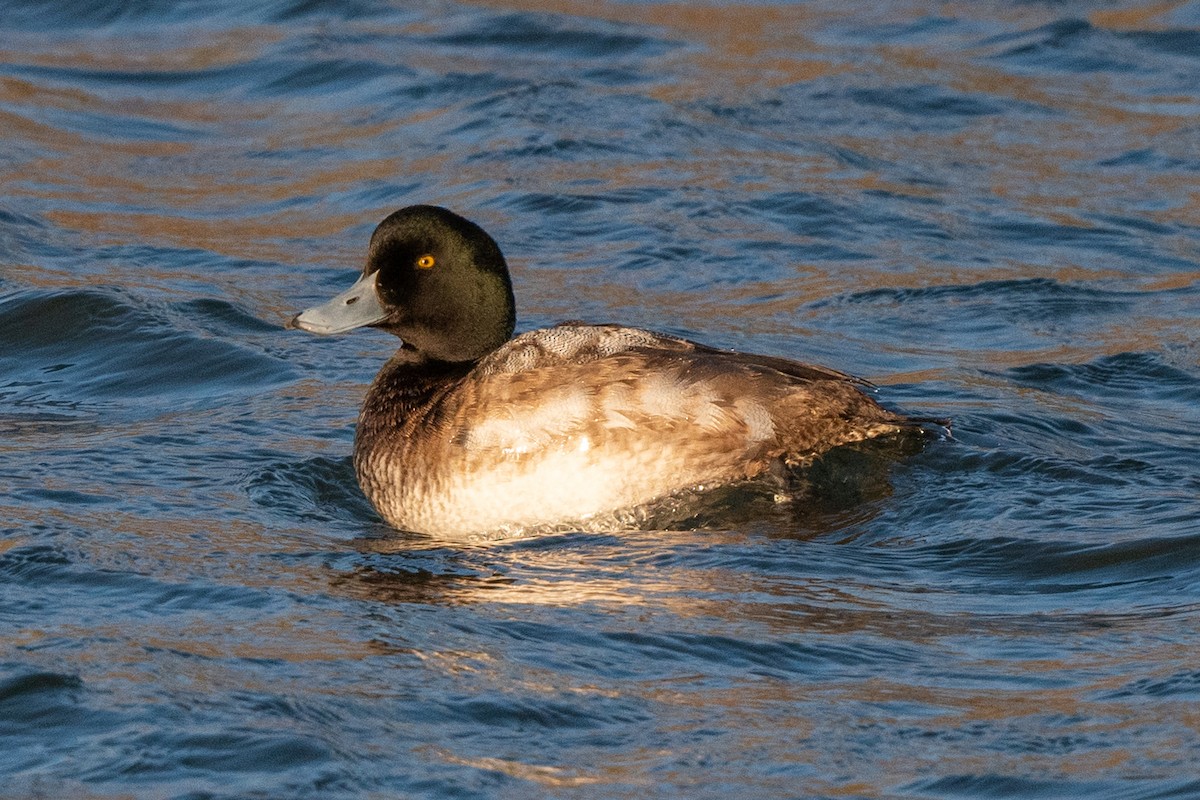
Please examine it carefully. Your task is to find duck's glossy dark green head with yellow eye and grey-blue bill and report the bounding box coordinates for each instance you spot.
[288,205,516,361]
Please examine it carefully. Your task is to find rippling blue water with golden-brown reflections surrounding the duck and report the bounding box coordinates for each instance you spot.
[0,0,1200,799]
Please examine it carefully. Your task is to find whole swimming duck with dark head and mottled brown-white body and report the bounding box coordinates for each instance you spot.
[287,205,920,540]
